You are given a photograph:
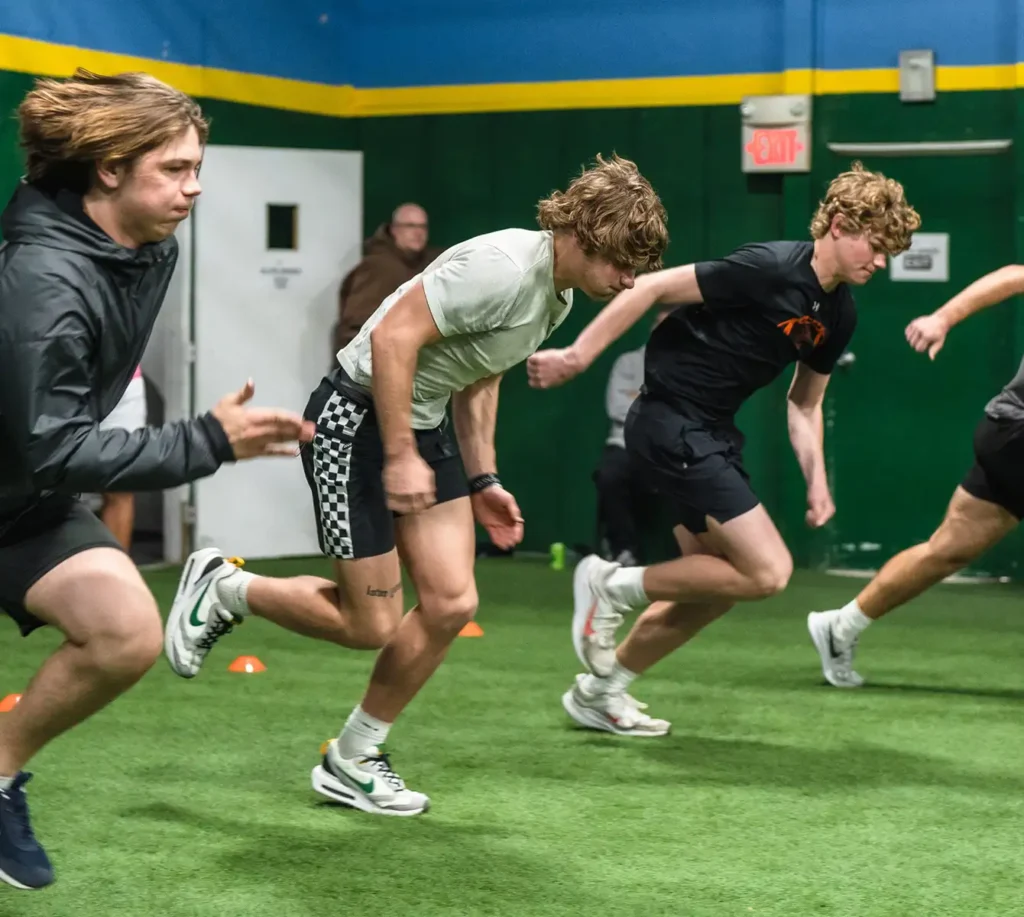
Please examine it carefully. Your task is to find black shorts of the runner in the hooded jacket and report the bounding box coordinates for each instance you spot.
[0,496,122,636]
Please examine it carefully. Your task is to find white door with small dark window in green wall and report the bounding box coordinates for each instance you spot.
[193,146,362,557]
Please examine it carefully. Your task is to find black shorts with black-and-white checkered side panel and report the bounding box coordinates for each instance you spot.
[302,368,469,560]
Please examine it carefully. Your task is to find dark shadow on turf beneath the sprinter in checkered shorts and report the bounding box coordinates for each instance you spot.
[122,802,598,915]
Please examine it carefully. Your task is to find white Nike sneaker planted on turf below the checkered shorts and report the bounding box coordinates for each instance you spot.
[312,739,430,816]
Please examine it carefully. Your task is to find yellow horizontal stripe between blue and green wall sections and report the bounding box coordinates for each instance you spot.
[0,35,1024,118]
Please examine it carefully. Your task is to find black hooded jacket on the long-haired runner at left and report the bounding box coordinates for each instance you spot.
[0,182,234,534]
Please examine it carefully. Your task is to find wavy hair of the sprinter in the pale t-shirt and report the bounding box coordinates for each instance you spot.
[537,154,669,271]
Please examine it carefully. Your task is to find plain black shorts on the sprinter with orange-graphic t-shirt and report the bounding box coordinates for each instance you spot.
[626,395,761,534]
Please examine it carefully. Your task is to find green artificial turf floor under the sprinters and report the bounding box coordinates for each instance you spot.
[0,560,1024,917]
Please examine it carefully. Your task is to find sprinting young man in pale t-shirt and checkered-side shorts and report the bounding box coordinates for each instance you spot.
[167,157,668,816]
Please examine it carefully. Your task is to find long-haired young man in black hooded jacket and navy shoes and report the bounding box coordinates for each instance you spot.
[0,71,312,888]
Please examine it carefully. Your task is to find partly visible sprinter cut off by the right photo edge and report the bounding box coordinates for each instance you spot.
[807,264,1024,688]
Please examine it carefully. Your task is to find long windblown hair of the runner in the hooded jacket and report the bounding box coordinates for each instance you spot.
[17,68,210,191]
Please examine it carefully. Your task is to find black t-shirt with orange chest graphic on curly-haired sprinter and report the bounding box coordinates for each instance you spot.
[644,242,857,424]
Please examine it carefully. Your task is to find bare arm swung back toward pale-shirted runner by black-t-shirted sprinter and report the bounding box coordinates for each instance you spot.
[526,264,703,389]
